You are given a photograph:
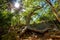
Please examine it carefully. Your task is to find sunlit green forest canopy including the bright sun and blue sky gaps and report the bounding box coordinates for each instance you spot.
[0,0,60,25]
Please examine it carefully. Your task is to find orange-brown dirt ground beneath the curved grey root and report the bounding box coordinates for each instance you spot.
[20,30,60,40]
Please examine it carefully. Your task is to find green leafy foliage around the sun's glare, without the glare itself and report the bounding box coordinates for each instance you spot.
[0,0,60,40]
